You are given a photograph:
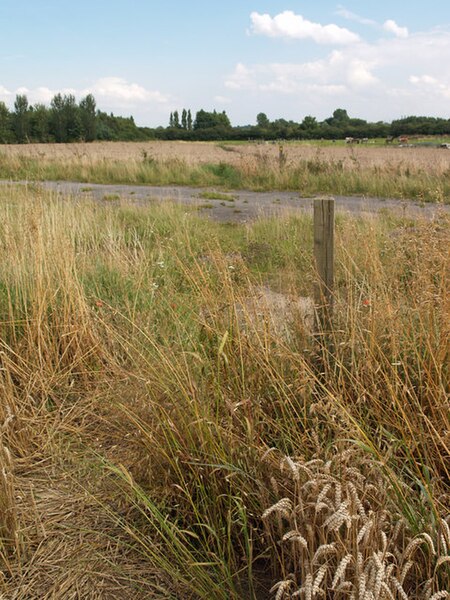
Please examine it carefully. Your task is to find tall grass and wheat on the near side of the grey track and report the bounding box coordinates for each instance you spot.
[0,184,450,600]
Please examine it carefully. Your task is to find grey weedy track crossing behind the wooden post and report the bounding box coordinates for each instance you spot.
[1,181,450,223]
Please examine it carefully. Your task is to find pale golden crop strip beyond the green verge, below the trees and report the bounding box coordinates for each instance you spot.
[0,141,449,174]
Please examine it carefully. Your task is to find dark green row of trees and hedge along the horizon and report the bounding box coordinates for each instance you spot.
[0,94,450,144]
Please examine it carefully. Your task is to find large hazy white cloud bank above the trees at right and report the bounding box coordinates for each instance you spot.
[225,29,450,120]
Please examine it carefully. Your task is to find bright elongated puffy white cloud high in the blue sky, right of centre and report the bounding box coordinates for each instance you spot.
[250,10,359,44]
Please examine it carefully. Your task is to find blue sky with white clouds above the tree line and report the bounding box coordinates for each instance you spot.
[0,0,450,126]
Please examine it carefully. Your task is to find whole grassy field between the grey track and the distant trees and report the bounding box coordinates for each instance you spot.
[0,142,450,203]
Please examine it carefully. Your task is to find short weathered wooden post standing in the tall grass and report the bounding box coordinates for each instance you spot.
[314,198,334,333]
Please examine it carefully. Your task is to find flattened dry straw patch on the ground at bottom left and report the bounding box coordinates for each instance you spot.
[0,462,169,600]
